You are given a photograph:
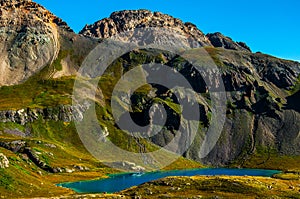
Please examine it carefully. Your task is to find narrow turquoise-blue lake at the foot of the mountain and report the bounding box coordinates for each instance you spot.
[58,168,280,193]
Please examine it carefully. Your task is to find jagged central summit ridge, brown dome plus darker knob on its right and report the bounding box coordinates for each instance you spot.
[80,9,251,52]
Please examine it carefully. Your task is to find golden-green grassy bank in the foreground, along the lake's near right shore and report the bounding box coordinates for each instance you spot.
[122,176,300,198]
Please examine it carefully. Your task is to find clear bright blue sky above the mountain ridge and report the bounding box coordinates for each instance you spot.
[33,0,300,61]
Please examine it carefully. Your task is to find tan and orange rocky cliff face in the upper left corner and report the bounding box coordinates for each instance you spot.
[0,0,71,85]
